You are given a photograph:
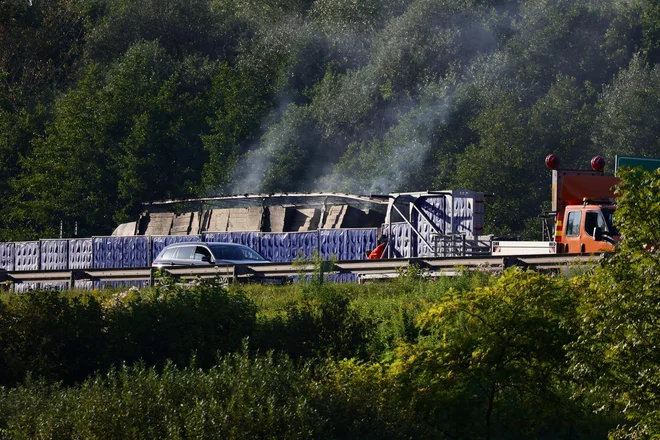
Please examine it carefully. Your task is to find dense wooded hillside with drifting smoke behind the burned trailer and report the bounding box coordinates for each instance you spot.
[0,0,660,240]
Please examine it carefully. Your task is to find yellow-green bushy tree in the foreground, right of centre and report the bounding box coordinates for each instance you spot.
[388,269,604,439]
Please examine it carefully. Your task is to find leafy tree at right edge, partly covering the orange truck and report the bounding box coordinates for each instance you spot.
[570,170,660,439]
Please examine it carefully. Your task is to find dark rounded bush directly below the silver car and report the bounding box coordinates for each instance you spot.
[106,282,256,367]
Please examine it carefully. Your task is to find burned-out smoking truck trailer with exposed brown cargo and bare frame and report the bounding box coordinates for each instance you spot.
[113,190,490,261]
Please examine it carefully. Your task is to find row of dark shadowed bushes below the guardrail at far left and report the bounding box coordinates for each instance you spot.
[0,283,256,385]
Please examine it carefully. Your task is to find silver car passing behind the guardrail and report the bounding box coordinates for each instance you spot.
[151,242,269,267]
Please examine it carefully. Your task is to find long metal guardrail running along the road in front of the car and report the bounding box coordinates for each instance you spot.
[0,254,602,288]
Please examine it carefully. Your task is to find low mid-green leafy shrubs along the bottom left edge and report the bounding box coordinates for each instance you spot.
[0,350,328,439]
